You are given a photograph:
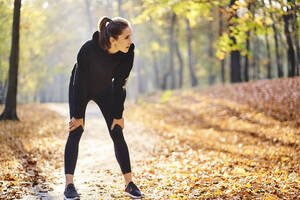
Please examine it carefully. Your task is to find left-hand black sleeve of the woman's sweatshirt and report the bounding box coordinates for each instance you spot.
[73,48,89,119]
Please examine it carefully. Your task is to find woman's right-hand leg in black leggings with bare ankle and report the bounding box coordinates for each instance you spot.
[95,89,132,185]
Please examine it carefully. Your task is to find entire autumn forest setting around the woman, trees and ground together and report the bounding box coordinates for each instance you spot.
[0,0,300,200]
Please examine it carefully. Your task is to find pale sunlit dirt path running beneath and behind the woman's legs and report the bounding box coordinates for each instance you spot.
[33,102,159,199]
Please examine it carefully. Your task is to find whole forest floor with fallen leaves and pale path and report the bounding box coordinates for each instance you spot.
[0,78,300,200]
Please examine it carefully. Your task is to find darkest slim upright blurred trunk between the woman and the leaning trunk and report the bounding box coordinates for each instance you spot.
[169,13,176,89]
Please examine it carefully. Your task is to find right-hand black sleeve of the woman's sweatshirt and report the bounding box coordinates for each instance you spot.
[113,43,135,119]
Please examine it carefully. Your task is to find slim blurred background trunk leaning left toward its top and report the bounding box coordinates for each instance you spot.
[185,19,198,87]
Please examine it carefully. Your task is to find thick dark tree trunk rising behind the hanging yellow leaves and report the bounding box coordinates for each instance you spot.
[229,0,242,83]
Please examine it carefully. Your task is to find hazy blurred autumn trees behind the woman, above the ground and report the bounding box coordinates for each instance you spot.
[0,0,300,104]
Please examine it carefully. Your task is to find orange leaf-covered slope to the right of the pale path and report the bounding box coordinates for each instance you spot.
[129,78,300,200]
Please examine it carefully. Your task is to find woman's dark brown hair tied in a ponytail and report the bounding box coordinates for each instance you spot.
[98,16,131,50]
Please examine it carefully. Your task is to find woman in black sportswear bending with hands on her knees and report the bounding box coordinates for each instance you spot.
[64,17,144,199]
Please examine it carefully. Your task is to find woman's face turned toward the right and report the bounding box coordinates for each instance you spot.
[113,26,132,53]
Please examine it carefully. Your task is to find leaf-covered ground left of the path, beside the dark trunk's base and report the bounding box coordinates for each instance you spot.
[0,104,65,200]
